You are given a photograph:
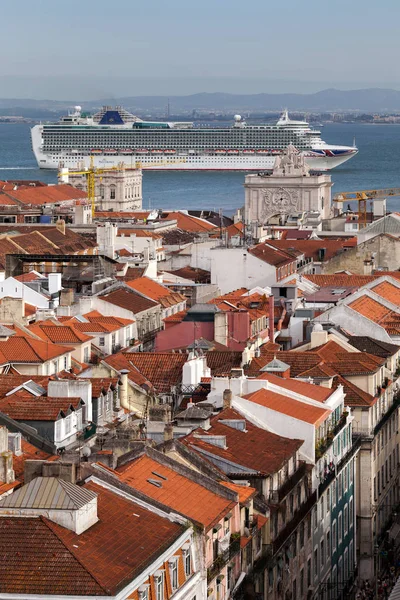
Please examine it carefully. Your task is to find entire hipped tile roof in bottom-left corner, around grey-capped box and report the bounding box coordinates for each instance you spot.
[0,482,184,596]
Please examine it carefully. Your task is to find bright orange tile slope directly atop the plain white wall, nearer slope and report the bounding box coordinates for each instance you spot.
[243,388,331,427]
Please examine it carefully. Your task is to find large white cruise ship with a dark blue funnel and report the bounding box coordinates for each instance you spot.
[31,106,358,171]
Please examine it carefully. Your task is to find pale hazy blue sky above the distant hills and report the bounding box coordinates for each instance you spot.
[0,0,400,100]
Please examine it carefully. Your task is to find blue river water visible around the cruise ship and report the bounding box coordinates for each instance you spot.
[0,123,400,214]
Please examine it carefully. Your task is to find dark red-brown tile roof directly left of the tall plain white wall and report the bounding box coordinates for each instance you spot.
[182,408,303,476]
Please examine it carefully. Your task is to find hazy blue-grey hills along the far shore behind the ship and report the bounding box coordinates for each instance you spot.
[0,88,400,114]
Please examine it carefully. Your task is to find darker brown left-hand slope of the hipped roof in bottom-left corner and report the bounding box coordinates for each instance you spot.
[0,517,106,596]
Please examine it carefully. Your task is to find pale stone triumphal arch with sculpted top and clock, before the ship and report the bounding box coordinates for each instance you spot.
[244,146,332,225]
